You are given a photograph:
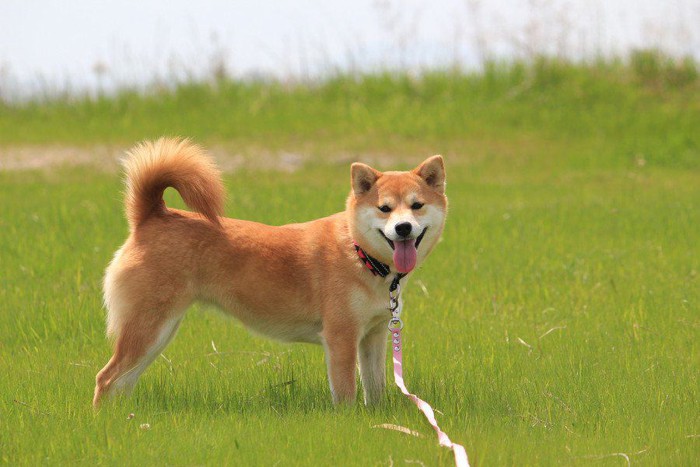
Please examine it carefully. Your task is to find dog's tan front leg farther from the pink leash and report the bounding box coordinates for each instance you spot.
[323,323,357,404]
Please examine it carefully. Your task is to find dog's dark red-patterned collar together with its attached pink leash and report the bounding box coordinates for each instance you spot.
[354,243,469,467]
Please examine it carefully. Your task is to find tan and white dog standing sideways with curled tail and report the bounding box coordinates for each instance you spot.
[93,139,447,405]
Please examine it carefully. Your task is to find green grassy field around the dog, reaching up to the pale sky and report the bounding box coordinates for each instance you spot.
[0,56,700,465]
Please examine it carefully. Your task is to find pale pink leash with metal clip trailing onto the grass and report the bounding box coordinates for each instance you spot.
[389,287,469,467]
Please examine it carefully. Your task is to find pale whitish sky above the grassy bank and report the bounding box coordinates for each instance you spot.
[0,0,700,97]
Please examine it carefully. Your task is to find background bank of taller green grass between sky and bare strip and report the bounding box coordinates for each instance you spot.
[0,56,700,168]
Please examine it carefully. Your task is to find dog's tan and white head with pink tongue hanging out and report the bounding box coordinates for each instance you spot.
[347,156,447,273]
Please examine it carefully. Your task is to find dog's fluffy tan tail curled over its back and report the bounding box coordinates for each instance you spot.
[124,138,224,231]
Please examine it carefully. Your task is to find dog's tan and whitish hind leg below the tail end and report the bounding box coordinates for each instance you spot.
[93,300,185,407]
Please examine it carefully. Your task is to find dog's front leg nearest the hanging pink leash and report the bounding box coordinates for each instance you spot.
[360,322,389,405]
